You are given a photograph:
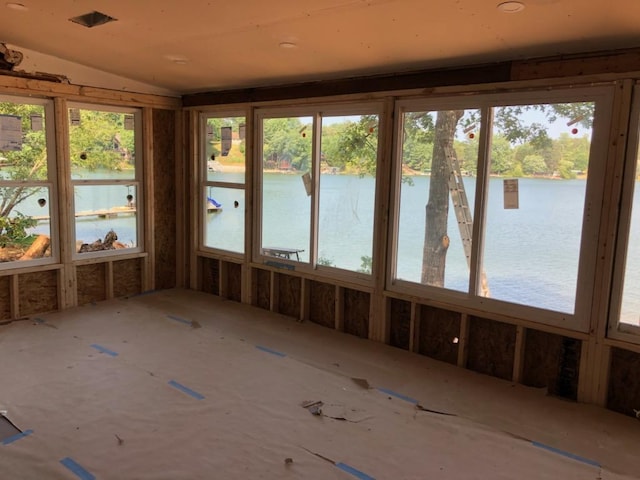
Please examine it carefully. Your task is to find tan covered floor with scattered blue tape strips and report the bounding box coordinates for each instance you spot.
[0,289,640,480]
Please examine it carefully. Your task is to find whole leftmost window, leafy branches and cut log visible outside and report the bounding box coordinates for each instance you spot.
[0,97,57,268]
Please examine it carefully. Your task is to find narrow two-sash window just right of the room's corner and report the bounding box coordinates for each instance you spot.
[199,113,246,254]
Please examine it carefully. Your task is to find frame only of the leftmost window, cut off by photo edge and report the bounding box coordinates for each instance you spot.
[0,94,60,271]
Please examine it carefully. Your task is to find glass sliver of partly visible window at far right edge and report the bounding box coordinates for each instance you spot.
[620,134,640,326]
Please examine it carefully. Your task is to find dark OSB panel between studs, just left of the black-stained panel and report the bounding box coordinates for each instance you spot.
[467,317,516,380]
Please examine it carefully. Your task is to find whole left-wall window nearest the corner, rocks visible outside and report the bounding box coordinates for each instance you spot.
[69,105,142,258]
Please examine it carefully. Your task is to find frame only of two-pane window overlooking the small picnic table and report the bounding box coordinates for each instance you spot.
[251,100,386,286]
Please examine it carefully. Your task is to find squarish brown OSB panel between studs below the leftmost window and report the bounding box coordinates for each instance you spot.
[18,270,58,316]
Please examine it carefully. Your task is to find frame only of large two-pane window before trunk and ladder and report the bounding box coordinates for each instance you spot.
[385,85,614,332]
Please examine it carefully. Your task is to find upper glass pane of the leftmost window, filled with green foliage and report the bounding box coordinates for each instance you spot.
[0,102,47,181]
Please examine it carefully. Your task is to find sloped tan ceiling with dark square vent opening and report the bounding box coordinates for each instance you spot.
[0,0,640,94]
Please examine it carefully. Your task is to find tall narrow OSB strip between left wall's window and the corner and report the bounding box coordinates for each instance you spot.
[153,109,176,289]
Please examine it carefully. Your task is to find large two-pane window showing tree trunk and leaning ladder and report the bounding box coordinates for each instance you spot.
[391,89,610,328]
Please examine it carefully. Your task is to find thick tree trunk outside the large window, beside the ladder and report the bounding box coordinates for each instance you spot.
[422,110,464,287]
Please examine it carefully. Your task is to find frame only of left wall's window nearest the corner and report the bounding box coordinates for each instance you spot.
[64,102,146,262]
